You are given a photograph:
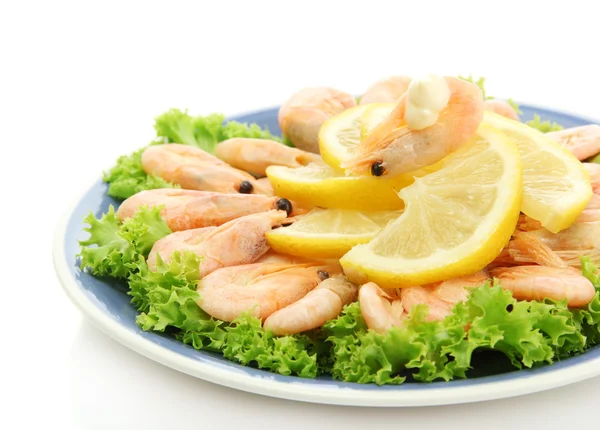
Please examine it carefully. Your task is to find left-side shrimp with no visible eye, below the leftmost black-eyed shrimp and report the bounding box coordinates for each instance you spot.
[148,210,287,277]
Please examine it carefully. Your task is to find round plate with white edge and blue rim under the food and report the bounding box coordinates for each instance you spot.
[53,105,600,407]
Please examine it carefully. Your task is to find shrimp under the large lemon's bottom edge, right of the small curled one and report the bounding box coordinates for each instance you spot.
[400,270,489,321]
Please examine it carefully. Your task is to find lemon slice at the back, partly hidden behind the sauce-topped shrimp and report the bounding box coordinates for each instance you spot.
[319,103,393,168]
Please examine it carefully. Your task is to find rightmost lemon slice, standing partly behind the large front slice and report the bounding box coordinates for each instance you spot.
[483,111,592,233]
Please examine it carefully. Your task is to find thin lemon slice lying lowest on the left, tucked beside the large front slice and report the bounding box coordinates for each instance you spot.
[266,209,402,258]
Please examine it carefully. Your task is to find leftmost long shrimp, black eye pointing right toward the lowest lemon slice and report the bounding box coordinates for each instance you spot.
[117,188,294,231]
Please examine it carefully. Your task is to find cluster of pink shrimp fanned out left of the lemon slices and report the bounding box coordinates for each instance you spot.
[117,136,358,335]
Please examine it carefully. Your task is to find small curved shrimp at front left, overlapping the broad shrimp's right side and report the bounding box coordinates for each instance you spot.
[263,275,358,336]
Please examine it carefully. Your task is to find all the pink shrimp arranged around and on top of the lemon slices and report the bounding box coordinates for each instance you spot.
[118,75,600,336]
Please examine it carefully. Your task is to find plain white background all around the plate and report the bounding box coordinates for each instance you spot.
[0,0,600,430]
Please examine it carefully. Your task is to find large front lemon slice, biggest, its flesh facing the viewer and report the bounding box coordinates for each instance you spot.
[341,125,522,288]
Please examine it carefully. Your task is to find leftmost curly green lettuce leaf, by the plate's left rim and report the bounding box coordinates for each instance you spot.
[77,205,171,278]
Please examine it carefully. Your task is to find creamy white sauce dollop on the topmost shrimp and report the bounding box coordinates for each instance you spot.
[404,75,450,130]
